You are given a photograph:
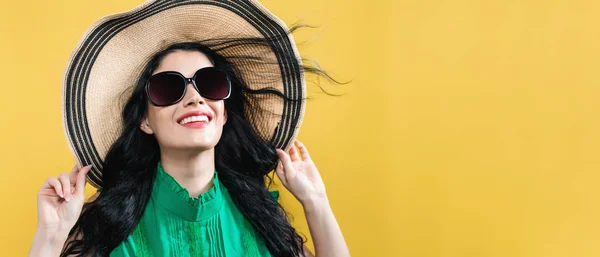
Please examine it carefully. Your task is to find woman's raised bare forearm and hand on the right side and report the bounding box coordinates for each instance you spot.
[275,141,350,257]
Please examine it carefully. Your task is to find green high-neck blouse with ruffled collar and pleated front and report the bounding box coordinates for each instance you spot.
[110,163,278,257]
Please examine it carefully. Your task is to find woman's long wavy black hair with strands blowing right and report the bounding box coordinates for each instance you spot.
[61,26,338,257]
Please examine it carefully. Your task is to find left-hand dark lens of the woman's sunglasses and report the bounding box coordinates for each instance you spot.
[148,73,186,105]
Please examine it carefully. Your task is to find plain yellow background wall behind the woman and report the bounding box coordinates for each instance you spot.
[0,0,600,257]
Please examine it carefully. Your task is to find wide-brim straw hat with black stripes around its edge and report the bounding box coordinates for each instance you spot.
[62,0,306,188]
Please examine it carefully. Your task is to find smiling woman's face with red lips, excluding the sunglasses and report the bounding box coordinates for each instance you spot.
[140,51,227,151]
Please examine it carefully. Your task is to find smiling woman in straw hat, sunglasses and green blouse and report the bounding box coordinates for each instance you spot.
[30,0,349,256]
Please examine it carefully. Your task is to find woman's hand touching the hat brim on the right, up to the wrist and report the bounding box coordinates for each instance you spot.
[275,140,327,205]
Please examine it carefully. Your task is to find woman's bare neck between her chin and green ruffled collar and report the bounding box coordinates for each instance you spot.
[160,148,215,198]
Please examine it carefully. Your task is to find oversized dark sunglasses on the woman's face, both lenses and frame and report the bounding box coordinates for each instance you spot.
[146,67,231,106]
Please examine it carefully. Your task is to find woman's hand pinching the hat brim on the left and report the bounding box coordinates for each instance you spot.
[38,165,91,234]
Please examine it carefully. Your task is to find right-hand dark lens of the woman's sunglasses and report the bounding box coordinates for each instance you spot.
[195,68,230,100]
